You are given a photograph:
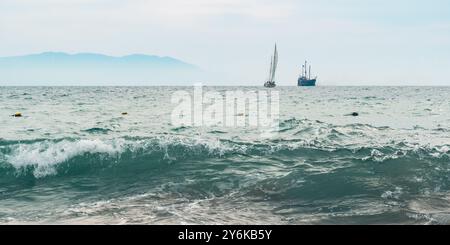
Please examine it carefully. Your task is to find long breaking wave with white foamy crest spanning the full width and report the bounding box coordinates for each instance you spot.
[0,136,450,178]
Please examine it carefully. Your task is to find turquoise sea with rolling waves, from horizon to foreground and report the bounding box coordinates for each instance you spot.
[0,87,450,224]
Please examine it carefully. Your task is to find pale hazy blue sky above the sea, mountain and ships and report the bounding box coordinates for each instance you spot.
[0,0,450,86]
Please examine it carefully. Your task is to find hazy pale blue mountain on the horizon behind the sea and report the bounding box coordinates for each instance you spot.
[0,52,201,85]
